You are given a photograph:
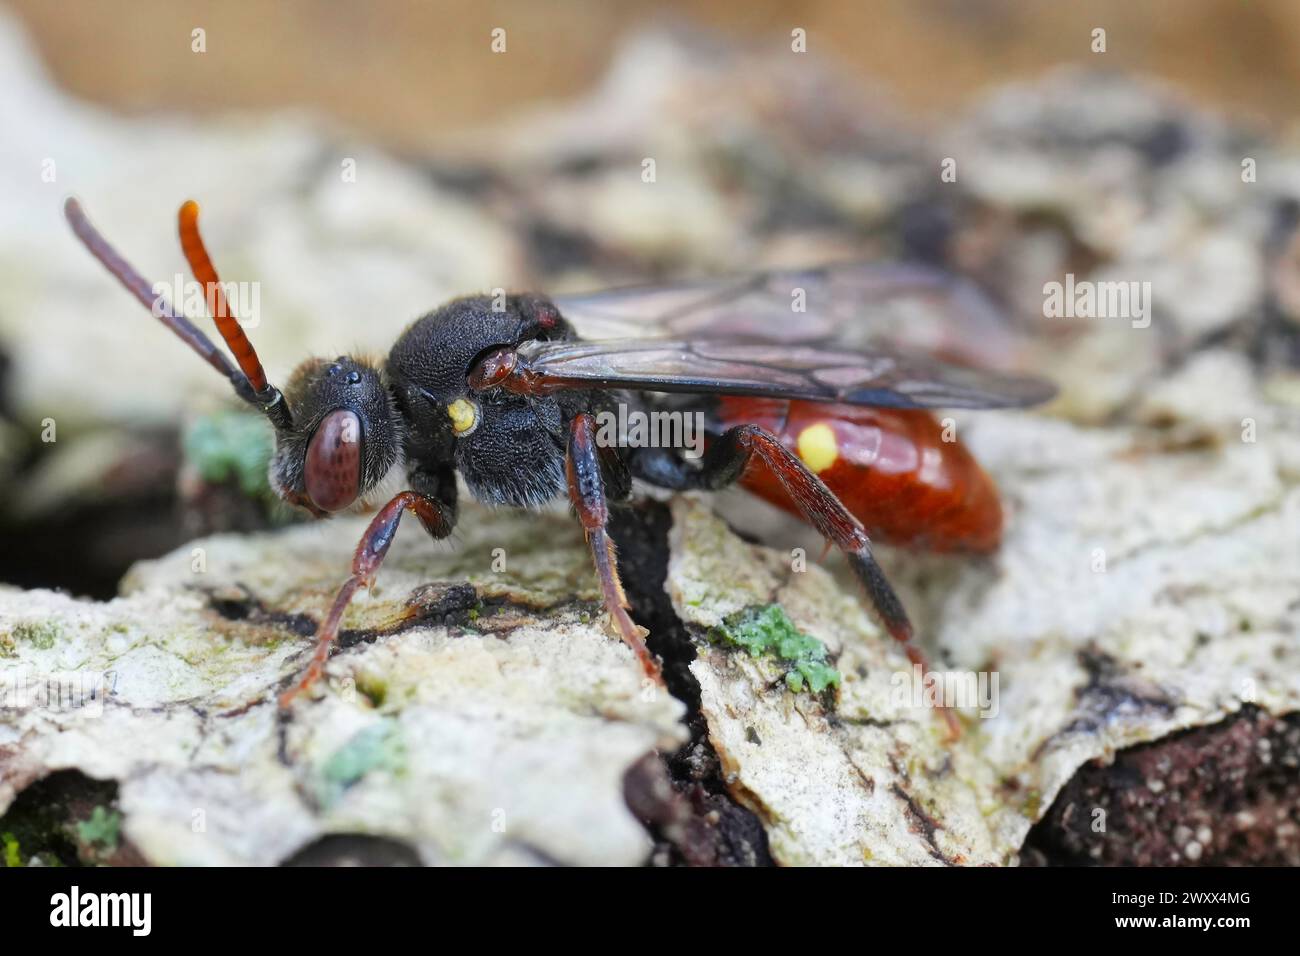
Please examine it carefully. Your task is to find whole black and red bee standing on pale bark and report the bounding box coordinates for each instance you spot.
[65,199,1054,732]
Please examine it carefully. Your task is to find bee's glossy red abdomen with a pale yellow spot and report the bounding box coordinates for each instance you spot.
[718,397,1002,551]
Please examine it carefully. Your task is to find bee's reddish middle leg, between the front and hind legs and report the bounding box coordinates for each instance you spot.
[564,412,663,683]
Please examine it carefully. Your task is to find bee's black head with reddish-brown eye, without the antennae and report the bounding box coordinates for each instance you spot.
[270,355,400,515]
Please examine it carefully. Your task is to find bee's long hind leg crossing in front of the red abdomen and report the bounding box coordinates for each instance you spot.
[632,425,961,739]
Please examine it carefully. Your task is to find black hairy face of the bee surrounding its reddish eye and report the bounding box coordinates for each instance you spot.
[270,355,402,510]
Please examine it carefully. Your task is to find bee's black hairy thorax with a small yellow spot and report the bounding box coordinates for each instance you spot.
[387,295,571,507]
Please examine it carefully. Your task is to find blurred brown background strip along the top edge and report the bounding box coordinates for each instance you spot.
[8,0,1300,147]
